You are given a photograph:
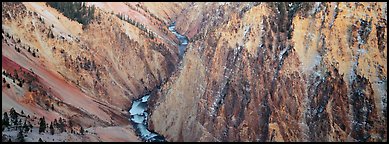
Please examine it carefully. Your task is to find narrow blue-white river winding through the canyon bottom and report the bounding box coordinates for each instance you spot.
[129,22,188,142]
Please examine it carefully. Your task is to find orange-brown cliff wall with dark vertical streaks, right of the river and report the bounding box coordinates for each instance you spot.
[149,3,387,141]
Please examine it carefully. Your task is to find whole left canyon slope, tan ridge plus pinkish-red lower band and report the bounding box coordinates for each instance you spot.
[2,3,185,141]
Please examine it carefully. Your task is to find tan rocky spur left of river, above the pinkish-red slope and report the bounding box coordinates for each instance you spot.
[3,0,178,118]
